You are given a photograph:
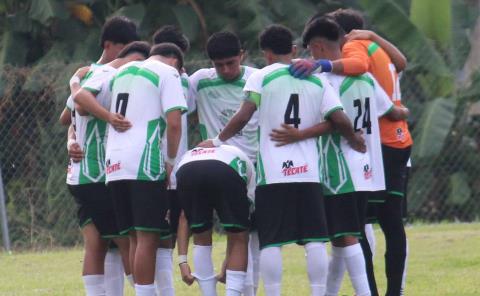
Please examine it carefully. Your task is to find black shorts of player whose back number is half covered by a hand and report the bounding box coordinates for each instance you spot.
[108,180,170,236]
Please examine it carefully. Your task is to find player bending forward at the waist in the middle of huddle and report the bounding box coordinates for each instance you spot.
[177,145,255,296]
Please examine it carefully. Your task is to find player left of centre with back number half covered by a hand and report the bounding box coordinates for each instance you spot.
[106,45,187,296]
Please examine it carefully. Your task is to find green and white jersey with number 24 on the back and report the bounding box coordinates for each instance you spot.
[319,73,393,195]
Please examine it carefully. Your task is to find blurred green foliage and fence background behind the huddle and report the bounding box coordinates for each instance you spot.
[0,0,480,248]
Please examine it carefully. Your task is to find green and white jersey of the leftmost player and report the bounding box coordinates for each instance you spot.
[67,65,117,185]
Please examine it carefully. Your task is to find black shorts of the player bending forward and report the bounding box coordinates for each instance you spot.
[177,160,250,233]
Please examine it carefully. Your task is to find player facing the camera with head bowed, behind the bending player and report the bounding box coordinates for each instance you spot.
[188,32,260,296]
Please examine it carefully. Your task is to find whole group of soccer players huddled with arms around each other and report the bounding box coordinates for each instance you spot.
[60,9,412,296]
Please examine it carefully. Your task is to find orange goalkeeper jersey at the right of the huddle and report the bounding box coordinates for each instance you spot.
[342,40,413,148]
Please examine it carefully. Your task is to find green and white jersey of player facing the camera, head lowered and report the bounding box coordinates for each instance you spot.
[190,66,258,161]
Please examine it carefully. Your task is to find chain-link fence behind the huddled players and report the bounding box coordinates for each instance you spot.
[0,51,480,249]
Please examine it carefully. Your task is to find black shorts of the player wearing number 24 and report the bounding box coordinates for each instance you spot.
[325,192,367,239]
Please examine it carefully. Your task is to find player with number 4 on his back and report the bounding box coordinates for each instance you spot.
[201,25,365,296]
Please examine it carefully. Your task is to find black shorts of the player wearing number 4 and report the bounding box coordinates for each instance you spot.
[255,183,329,249]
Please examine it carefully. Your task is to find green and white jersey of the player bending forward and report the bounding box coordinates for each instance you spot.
[176,145,256,201]
